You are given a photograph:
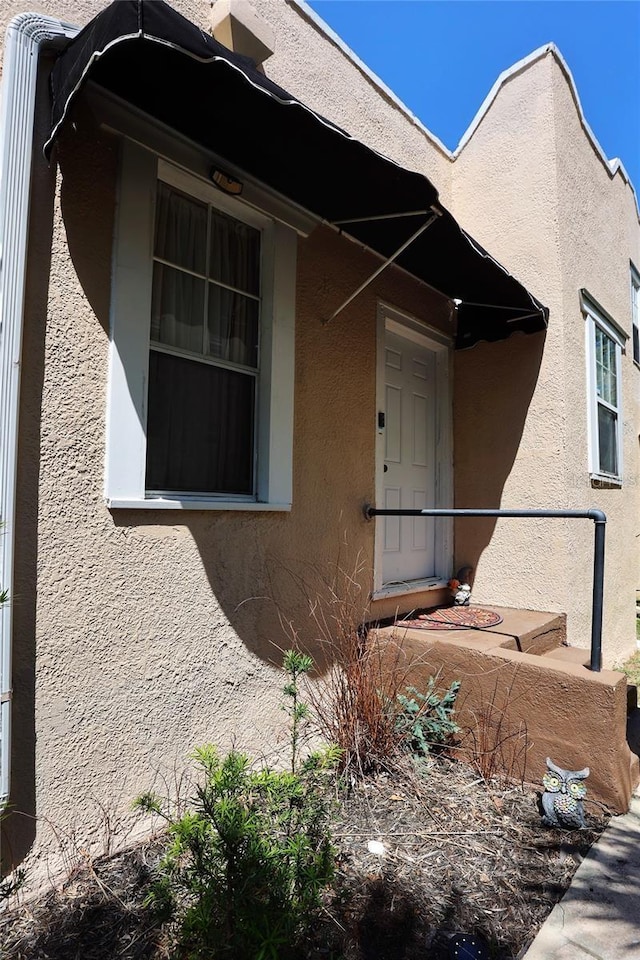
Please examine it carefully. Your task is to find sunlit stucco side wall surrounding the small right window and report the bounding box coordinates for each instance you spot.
[549,58,640,662]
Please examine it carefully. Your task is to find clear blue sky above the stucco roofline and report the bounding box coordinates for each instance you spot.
[307,0,640,192]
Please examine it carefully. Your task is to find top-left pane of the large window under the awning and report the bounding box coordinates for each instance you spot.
[154,181,207,274]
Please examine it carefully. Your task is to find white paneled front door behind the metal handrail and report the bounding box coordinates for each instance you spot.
[382,331,436,584]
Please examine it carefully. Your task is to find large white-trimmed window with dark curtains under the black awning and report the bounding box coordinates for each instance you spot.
[106,141,297,510]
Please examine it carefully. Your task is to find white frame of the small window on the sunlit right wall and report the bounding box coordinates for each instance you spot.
[580,291,627,486]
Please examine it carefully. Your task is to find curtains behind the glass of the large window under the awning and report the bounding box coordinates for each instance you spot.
[146,183,260,494]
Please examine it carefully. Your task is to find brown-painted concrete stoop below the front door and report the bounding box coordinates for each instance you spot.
[371,606,640,813]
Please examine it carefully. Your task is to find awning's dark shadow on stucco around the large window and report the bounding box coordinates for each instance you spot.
[53,114,378,670]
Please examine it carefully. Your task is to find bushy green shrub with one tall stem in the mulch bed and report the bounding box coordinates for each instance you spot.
[136,651,337,960]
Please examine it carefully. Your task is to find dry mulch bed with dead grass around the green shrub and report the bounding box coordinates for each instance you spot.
[0,757,606,960]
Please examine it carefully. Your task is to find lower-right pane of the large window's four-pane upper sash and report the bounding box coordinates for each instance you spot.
[209,283,260,367]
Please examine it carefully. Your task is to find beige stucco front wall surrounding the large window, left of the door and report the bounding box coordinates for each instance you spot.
[4,4,450,879]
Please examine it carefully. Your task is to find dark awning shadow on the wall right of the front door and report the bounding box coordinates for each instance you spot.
[454,333,546,571]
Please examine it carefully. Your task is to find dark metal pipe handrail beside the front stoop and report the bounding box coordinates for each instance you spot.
[363,503,607,673]
